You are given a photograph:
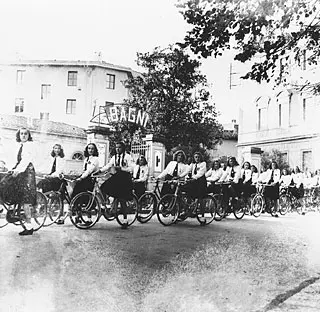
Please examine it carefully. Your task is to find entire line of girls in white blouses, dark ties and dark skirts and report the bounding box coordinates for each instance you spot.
[0,128,320,235]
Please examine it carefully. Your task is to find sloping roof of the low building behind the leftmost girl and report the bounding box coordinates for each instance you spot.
[0,114,87,138]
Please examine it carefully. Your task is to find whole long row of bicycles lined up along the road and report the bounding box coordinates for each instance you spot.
[0,177,320,231]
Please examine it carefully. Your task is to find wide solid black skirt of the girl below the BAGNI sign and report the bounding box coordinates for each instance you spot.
[100,171,133,200]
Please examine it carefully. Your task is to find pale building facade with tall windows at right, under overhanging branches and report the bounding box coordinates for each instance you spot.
[238,53,320,171]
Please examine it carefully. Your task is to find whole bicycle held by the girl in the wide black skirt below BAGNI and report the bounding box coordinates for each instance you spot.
[70,175,138,229]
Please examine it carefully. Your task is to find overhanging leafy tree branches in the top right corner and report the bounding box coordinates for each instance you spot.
[178,0,320,92]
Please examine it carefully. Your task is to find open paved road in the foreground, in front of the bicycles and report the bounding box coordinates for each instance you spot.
[0,213,320,312]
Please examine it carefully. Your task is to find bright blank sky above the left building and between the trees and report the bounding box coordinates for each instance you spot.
[0,0,238,123]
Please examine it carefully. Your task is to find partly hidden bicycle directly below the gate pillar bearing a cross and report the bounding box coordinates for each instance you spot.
[137,180,161,223]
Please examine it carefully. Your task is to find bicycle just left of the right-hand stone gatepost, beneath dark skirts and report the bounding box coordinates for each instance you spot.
[213,182,245,221]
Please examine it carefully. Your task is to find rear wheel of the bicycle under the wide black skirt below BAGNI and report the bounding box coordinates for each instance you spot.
[113,196,138,226]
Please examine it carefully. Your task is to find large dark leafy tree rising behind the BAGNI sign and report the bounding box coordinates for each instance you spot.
[125,46,222,150]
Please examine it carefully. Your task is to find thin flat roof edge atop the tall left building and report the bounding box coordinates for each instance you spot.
[2,60,135,73]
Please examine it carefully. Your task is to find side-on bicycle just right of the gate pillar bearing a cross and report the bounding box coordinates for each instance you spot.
[157,180,216,226]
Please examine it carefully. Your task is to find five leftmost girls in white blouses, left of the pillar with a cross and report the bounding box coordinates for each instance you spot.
[0,128,148,235]
